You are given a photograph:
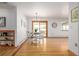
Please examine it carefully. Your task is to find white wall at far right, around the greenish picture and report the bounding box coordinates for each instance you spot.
[68,3,79,55]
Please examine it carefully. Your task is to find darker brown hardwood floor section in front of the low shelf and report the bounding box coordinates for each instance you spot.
[0,46,19,56]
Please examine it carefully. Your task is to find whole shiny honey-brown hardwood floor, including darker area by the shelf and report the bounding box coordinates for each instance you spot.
[0,38,75,56]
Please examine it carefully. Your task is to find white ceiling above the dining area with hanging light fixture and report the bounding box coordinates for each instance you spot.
[9,2,68,18]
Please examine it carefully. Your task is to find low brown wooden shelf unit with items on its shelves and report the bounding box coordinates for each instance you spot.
[0,30,15,46]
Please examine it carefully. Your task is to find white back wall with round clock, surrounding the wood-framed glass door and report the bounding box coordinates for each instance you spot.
[28,18,68,37]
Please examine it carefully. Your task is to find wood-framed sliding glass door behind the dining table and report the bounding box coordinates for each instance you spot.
[32,21,48,37]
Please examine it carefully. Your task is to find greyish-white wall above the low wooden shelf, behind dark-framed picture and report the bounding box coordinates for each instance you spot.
[0,4,16,29]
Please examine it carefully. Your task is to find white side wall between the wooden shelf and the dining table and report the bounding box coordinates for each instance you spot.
[15,5,27,47]
